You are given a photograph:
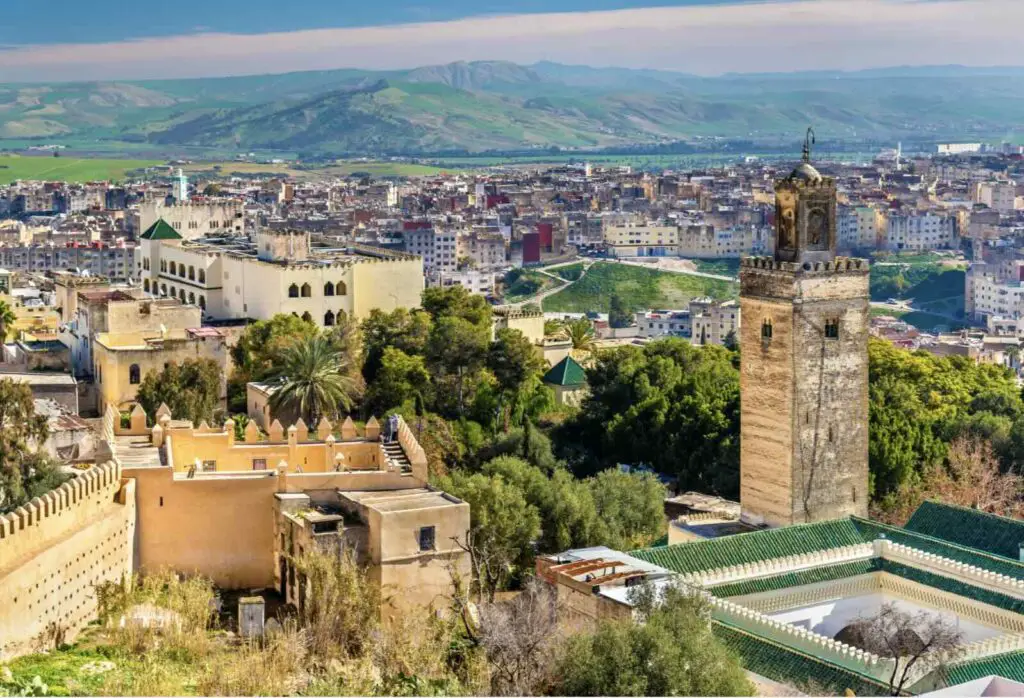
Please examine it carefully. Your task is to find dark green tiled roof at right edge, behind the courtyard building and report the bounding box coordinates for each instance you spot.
[904,501,1024,560]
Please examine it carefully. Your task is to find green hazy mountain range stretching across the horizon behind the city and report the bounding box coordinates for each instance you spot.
[0,61,1024,155]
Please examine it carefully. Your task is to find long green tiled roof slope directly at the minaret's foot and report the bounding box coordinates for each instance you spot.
[630,519,864,573]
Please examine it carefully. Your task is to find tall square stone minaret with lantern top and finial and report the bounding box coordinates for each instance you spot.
[739,130,868,526]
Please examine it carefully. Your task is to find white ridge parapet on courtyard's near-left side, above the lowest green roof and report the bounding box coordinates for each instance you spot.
[709,598,893,681]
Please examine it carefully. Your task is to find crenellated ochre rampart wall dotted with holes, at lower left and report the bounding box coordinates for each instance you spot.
[0,463,135,659]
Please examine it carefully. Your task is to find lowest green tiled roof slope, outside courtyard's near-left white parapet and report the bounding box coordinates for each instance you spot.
[712,621,889,696]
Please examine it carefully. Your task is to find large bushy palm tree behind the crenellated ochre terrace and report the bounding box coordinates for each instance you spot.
[270,335,357,426]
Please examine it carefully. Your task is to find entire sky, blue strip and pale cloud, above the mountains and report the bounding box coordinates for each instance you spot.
[0,0,1024,83]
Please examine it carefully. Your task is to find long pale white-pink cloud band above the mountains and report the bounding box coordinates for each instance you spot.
[0,0,1024,82]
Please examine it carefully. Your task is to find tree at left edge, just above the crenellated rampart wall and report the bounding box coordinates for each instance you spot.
[0,379,69,514]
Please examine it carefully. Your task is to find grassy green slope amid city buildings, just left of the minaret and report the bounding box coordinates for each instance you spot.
[544,262,738,312]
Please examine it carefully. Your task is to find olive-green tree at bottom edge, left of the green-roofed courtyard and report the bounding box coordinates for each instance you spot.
[554,587,753,696]
